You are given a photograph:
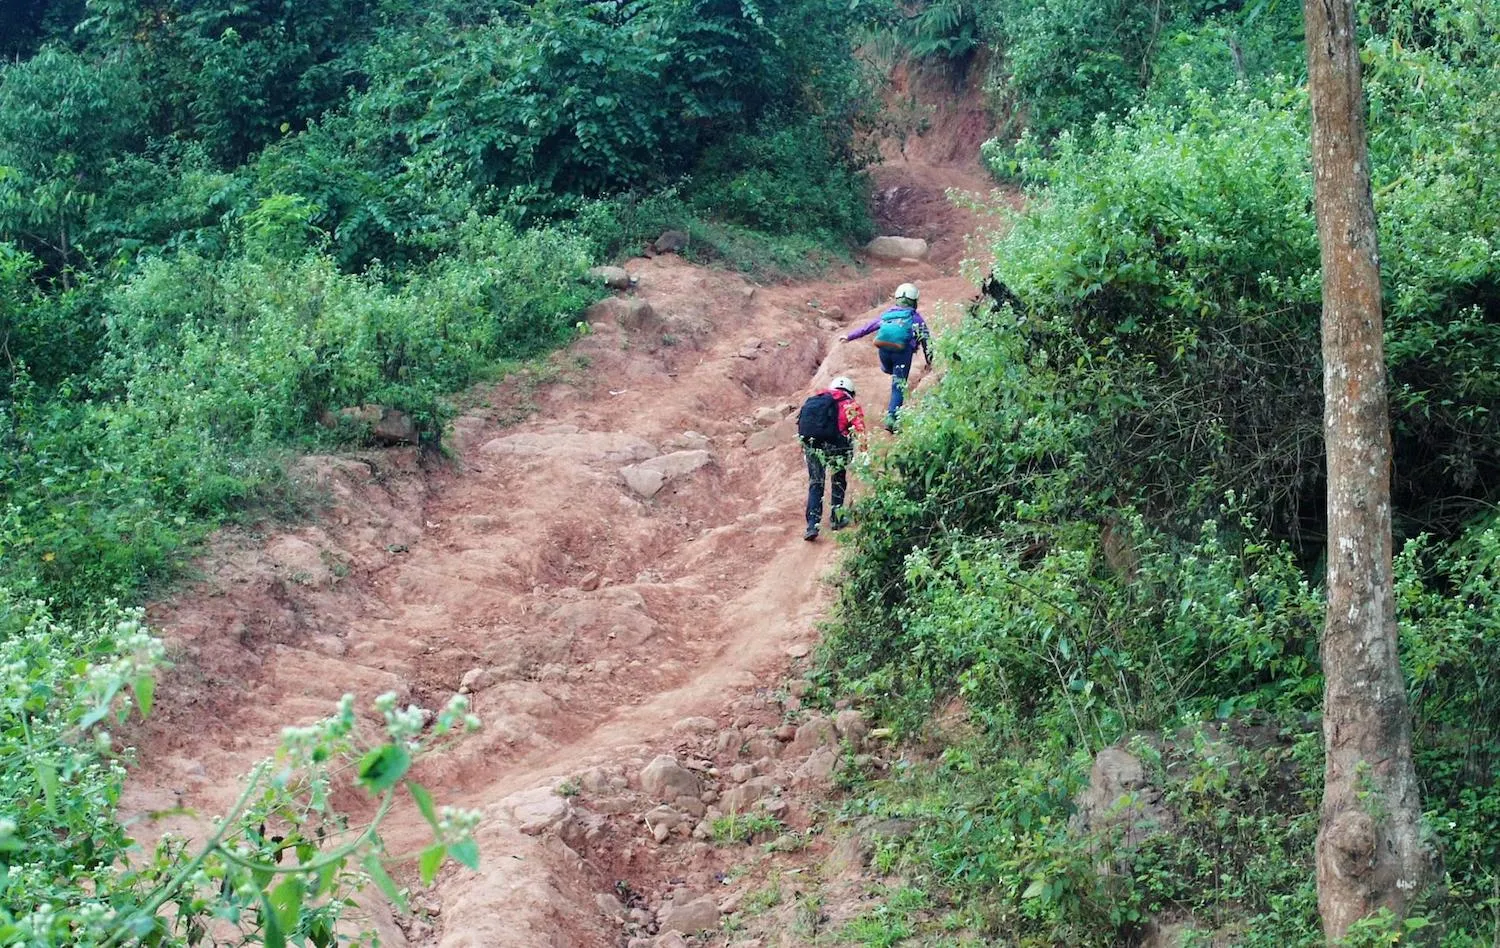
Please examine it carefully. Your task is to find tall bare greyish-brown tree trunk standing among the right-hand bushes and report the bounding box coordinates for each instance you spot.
[1304,0,1433,942]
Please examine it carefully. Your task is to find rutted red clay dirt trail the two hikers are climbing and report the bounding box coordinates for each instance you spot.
[125,129,992,948]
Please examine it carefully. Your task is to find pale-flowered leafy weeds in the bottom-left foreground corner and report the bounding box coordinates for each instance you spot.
[0,590,479,947]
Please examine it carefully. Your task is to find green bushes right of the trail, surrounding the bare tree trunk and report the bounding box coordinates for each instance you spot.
[825,3,1500,945]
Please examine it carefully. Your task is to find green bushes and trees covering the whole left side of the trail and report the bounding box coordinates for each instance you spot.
[0,0,869,945]
